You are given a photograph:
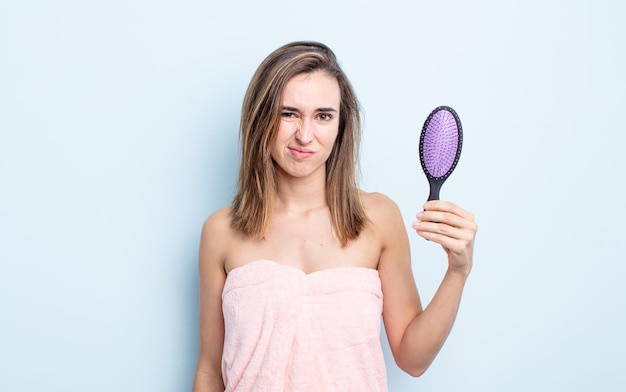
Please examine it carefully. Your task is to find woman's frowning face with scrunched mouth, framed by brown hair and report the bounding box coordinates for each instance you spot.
[271,72,341,181]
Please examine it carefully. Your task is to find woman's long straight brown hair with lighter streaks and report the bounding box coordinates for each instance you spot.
[231,42,367,246]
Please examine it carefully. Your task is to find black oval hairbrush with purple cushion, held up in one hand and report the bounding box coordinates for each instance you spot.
[419,106,463,200]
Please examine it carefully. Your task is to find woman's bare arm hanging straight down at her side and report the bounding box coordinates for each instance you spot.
[193,210,229,392]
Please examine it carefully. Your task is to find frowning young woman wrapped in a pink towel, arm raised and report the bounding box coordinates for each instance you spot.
[194,42,477,392]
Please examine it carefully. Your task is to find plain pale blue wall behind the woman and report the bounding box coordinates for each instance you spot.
[0,0,626,392]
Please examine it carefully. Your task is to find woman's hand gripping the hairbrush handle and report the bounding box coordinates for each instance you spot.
[413,200,478,274]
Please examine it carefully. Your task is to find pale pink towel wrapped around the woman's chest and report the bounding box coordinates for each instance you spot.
[222,260,387,392]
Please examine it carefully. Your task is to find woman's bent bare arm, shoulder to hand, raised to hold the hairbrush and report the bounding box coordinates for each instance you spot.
[372,201,477,376]
